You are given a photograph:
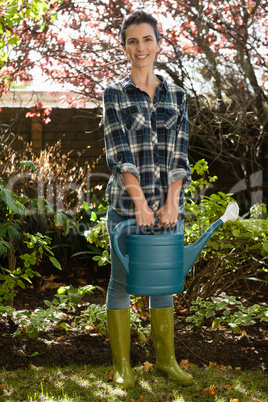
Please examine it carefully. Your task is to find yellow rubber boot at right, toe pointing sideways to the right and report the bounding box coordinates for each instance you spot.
[150,307,193,386]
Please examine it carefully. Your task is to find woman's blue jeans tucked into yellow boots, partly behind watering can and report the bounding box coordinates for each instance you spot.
[106,207,177,310]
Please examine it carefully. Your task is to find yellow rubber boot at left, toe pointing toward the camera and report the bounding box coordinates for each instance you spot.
[107,308,135,389]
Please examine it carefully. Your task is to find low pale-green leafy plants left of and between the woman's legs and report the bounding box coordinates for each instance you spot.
[11,285,150,343]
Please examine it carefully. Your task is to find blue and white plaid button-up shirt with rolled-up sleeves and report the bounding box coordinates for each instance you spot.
[103,76,191,219]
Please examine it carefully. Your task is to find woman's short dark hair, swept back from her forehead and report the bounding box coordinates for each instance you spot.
[120,11,160,46]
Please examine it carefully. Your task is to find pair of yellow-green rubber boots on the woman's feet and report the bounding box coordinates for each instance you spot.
[107,307,193,389]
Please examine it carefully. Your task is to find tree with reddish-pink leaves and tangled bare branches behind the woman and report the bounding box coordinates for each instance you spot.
[2,0,268,207]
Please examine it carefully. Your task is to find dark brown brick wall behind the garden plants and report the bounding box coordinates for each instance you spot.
[0,107,268,209]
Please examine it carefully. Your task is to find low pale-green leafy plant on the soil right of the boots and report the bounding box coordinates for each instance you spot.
[186,296,268,332]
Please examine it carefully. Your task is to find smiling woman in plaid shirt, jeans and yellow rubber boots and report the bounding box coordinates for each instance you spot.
[104,11,193,388]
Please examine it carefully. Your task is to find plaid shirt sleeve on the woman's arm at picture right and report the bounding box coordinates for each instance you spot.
[168,93,191,190]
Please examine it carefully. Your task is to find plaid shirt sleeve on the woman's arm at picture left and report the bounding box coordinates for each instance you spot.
[103,87,140,189]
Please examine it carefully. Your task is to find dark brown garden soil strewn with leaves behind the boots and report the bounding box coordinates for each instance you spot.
[0,268,268,371]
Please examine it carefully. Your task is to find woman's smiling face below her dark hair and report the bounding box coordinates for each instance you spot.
[123,23,161,68]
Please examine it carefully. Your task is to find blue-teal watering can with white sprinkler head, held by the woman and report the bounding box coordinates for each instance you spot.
[111,202,239,296]
